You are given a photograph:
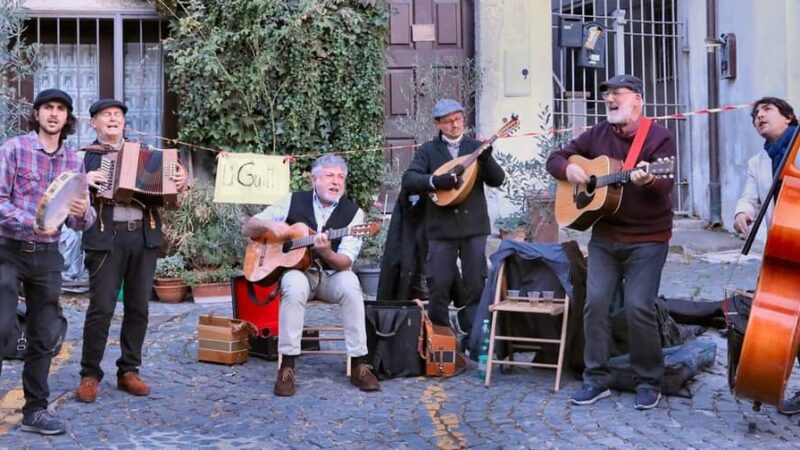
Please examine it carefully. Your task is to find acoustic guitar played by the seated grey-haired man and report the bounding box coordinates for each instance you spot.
[242,221,381,284]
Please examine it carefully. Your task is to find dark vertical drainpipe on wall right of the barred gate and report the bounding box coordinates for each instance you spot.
[706,0,722,226]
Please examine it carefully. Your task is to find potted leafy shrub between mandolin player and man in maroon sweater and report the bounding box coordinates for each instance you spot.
[494,105,571,242]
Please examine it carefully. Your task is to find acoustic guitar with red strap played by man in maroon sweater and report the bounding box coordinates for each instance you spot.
[555,155,675,231]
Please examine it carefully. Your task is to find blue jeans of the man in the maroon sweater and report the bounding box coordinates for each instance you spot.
[583,236,669,390]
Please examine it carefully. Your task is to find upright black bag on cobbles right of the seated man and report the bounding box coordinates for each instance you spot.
[364,301,425,379]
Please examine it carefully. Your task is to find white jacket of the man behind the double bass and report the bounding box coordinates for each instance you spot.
[733,150,775,242]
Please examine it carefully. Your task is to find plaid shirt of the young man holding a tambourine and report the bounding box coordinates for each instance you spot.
[0,131,96,243]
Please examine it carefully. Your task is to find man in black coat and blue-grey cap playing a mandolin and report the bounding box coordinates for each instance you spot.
[403,99,505,348]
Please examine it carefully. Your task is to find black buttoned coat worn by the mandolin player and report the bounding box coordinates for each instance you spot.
[403,135,506,240]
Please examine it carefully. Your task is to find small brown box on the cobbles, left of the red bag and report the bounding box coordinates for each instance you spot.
[197,314,258,365]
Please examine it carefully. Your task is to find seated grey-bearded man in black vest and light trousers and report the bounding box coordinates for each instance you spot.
[242,155,380,397]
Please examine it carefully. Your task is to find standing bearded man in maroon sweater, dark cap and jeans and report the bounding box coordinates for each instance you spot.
[546,75,675,410]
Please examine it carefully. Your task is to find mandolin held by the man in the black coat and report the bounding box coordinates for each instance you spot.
[428,114,519,206]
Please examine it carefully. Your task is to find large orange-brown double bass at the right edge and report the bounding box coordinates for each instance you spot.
[733,126,800,409]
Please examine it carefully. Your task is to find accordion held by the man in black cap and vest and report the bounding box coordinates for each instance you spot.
[97,142,178,209]
